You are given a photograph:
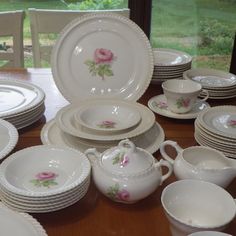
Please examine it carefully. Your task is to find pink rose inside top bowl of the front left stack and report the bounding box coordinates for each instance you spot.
[30,171,58,188]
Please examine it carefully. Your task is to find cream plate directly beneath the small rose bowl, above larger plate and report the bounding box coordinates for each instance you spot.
[56,103,155,141]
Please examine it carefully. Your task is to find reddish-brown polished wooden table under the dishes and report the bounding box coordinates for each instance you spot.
[0,69,236,236]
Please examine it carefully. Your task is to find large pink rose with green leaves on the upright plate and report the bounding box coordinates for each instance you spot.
[84,48,115,80]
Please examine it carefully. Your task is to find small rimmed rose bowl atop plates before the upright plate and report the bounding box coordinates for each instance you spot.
[74,100,141,132]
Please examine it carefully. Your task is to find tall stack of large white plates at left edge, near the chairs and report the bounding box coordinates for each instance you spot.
[0,79,45,129]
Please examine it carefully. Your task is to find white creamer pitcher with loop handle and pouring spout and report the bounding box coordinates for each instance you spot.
[160,140,236,188]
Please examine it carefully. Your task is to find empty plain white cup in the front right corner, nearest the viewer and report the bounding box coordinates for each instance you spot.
[161,179,236,236]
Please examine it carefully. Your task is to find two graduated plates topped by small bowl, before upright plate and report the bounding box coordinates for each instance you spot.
[41,99,164,153]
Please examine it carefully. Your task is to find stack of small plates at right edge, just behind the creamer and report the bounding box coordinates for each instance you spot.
[194,106,236,158]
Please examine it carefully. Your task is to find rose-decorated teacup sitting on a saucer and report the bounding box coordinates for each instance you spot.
[162,79,209,113]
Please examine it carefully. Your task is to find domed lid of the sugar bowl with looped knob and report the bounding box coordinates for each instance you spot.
[101,139,154,175]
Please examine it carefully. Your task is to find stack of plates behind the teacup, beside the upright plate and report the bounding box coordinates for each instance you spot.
[152,48,192,82]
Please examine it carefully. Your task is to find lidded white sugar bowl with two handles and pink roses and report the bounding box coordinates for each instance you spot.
[85,139,173,203]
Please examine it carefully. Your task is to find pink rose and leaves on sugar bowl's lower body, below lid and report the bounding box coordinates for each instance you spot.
[107,183,130,202]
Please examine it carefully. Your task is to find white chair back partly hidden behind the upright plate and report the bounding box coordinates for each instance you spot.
[29,8,130,67]
